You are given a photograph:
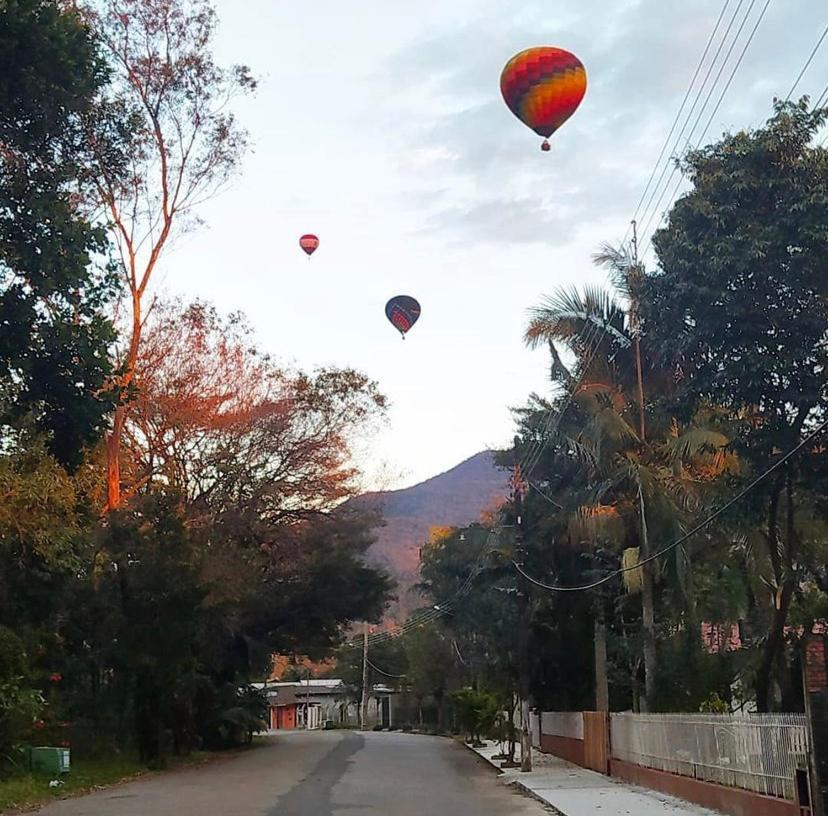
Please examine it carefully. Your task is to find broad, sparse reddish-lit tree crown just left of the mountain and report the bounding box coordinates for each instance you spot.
[123,303,386,516]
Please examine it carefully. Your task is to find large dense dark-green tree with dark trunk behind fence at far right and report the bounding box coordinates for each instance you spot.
[643,99,828,711]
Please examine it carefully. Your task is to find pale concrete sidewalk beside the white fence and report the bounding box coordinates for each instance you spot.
[474,745,721,816]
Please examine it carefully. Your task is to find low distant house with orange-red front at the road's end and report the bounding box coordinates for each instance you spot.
[254,679,396,731]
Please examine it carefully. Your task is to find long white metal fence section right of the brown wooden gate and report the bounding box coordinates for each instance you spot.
[610,714,808,800]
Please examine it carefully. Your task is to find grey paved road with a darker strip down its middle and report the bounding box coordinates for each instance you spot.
[39,731,548,816]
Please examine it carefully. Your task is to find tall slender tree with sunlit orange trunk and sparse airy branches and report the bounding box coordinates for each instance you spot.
[86,0,255,509]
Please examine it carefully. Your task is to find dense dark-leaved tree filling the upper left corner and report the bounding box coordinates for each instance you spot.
[0,0,118,466]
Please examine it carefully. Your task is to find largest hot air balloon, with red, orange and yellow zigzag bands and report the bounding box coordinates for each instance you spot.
[500,46,586,151]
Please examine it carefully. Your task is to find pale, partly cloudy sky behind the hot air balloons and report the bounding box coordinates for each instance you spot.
[152,0,828,486]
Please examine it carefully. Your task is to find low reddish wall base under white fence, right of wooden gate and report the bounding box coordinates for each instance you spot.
[610,759,799,816]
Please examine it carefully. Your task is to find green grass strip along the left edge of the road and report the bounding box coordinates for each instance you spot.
[0,751,221,813]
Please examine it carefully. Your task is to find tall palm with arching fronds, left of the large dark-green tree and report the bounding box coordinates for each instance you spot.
[525,246,728,709]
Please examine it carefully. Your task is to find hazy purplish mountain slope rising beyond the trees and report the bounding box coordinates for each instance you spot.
[354,451,509,617]
